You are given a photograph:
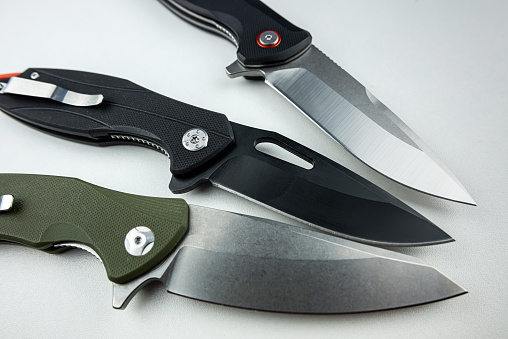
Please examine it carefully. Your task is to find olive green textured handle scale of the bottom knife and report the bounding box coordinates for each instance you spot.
[0,174,188,284]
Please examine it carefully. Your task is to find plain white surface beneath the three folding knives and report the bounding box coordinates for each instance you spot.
[0,0,508,338]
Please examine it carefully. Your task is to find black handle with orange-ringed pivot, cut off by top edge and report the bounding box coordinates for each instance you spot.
[171,0,312,66]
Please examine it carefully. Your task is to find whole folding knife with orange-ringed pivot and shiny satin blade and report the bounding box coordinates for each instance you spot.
[159,0,475,205]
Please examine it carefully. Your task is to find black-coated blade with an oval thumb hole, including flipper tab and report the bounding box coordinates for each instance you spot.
[170,123,453,246]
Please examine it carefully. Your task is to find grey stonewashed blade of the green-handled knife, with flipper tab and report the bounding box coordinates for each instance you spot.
[114,206,466,313]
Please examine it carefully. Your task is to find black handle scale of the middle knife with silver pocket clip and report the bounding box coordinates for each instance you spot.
[0,69,234,174]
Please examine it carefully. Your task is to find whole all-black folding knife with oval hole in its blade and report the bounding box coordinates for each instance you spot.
[0,69,453,246]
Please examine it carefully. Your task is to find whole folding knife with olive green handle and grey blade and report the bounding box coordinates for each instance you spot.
[0,174,467,313]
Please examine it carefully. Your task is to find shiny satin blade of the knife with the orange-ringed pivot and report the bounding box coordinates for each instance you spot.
[227,45,475,205]
